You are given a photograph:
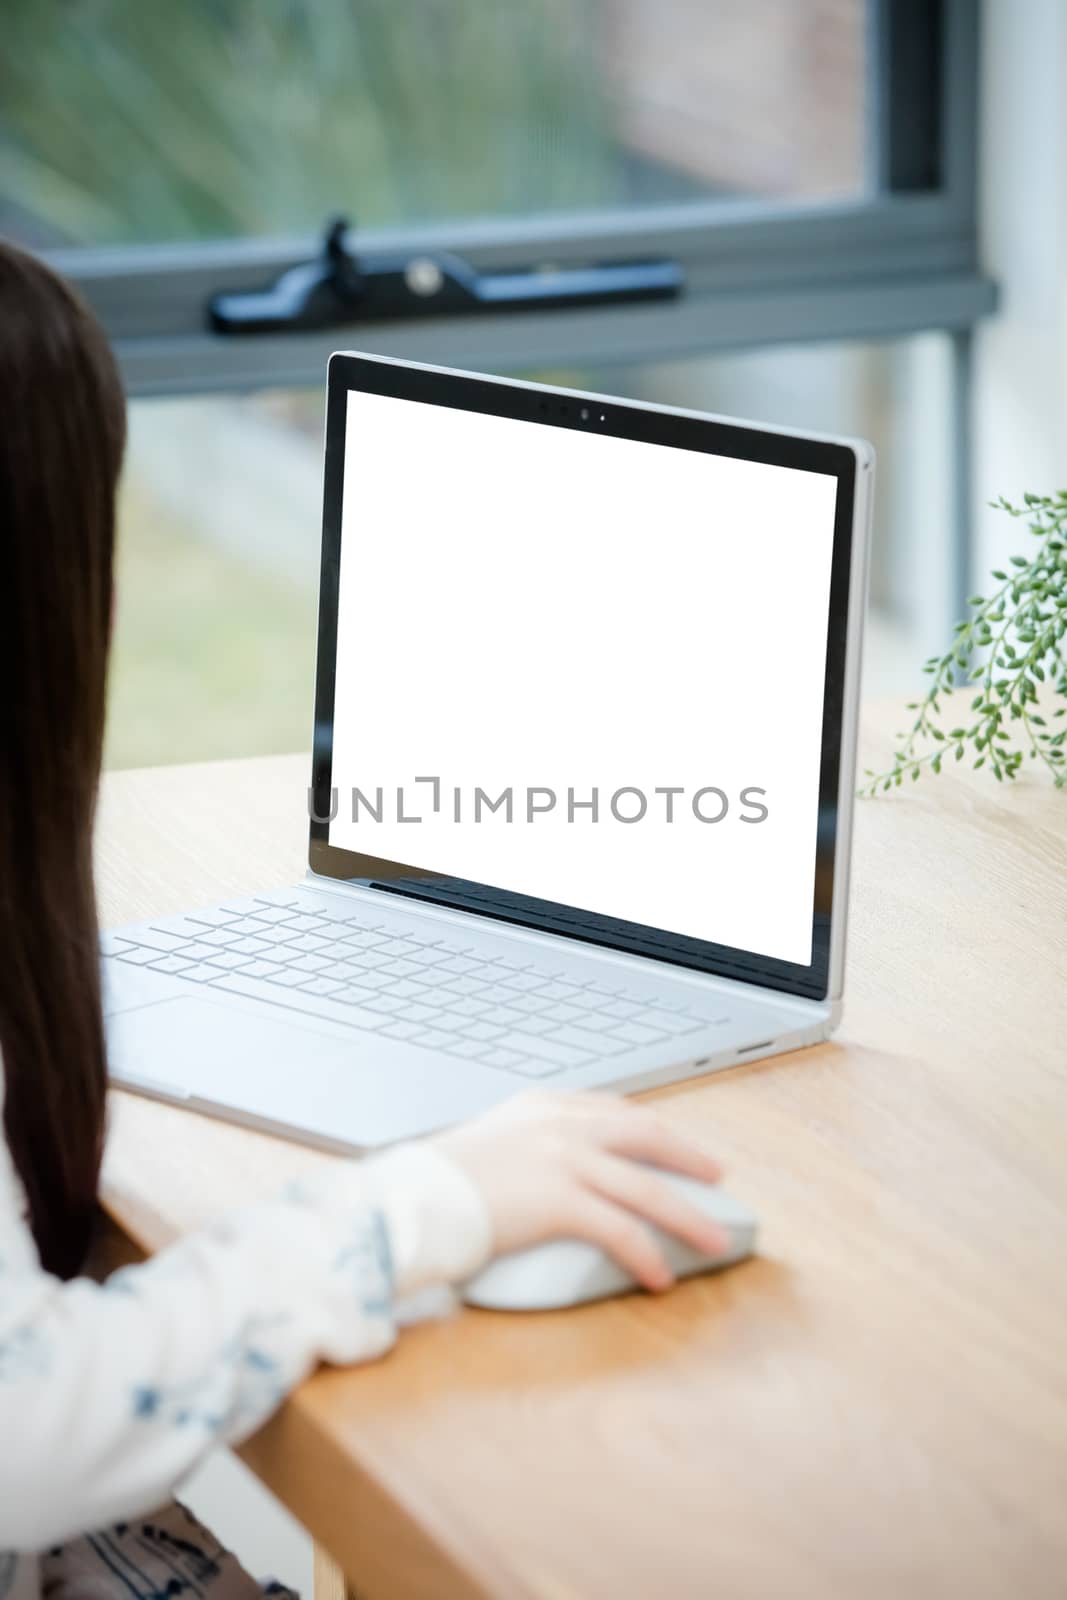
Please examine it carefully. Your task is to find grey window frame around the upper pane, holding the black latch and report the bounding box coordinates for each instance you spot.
[39,0,997,395]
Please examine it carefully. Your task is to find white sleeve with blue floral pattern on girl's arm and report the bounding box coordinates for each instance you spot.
[0,1141,490,1550]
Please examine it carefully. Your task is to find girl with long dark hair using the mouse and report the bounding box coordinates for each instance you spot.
[0,243,725,1600]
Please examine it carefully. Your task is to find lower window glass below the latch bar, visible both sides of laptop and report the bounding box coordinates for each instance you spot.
[107,334,953,766]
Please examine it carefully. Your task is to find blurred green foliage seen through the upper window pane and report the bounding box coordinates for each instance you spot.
[0,0,624,243]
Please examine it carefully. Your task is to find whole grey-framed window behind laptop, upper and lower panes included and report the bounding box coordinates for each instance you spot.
[0,0,995,765]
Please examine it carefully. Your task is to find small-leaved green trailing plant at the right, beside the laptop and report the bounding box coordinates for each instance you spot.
[861,490,1067,795]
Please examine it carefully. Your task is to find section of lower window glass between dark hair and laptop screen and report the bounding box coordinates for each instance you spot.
[104,392,323,766]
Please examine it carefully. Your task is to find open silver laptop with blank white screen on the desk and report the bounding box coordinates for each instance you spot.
[104,354,873,1150]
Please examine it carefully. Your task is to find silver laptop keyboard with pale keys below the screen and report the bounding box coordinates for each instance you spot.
[102,894,726,1078]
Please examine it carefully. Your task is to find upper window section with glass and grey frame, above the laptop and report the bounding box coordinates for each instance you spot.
[0,0,993,394]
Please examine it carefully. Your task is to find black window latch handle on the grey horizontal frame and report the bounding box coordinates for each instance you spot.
[208,218,683,334]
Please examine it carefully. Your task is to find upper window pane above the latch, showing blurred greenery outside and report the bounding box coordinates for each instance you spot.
[0,0,865,246]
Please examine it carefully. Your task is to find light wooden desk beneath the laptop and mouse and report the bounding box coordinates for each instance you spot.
[99,712,1067,1600]
